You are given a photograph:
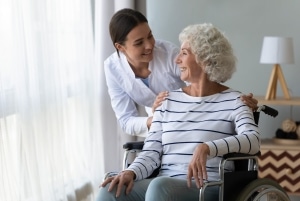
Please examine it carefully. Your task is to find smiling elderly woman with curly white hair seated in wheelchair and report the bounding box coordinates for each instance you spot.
[97,24,260,201]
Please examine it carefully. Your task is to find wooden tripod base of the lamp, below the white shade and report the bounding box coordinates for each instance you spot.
[265,64,291,100]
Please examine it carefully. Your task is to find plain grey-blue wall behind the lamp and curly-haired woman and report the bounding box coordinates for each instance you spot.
[146,0,300,138]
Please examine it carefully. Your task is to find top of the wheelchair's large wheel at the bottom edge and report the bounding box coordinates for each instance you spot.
[236,178,290,201]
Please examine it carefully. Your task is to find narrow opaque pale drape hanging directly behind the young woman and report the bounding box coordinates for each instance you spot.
[95,0,137,172]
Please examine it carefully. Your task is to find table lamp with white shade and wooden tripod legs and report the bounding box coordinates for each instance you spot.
[260,36,294,100]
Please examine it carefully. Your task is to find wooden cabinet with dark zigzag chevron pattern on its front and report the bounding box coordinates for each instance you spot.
[258,139,300,195]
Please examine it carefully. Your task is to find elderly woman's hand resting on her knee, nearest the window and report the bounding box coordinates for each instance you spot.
[101,170,135,197]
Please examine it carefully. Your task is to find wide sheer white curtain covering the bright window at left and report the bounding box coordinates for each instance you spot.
[0,0,104,201]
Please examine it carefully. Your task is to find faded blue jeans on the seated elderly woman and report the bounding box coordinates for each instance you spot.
[96,177,219,201]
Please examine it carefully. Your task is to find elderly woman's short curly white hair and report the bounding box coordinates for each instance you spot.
[179,23,236,83]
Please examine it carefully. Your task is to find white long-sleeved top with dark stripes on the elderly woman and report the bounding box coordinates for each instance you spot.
[128,89,260,180]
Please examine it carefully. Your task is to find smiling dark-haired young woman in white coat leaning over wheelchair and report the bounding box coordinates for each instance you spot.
[104,8,257,136]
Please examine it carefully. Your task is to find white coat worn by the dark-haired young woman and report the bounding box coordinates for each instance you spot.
[104,40,185,135]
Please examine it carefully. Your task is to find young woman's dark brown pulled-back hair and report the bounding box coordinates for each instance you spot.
[109,8,148,56]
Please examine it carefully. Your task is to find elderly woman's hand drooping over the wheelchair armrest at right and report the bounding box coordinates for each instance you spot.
[187,143,209,188]
